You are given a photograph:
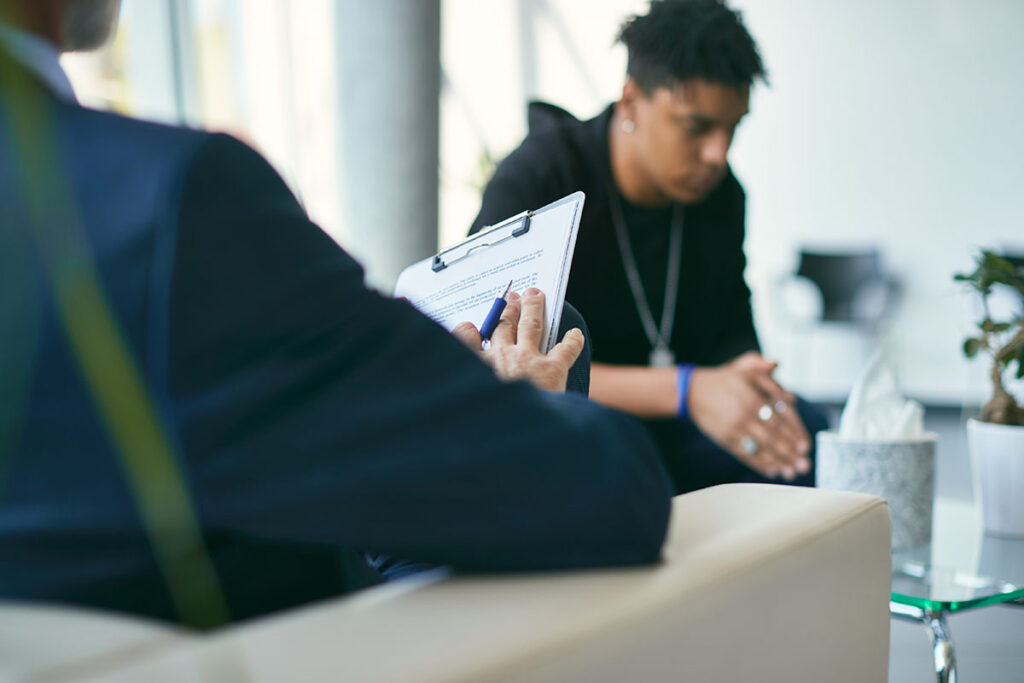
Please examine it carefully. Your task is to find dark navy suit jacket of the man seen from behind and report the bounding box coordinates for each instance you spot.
[0,50,670,620]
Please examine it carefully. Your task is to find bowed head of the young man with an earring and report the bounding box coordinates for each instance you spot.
[615,0,765,204]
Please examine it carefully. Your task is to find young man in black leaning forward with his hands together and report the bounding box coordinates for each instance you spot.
[471,0,825,490]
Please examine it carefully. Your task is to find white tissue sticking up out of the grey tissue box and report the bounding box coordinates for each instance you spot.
[839,351,925,441]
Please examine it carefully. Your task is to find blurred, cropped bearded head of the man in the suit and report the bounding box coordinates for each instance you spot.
[0,0,121,52]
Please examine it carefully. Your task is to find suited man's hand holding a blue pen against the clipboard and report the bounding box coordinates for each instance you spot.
[452,287,584,391]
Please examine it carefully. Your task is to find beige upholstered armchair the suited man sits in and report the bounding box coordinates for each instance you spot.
[6,484,890,683]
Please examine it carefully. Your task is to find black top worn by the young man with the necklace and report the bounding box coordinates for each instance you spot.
[470,102,758,365]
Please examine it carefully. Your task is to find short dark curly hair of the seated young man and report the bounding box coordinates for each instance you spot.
[617,0,768,95]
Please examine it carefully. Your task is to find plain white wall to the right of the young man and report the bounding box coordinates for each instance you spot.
[733,0,1024,402]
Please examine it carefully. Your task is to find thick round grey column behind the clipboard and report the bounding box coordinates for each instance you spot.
[335,0,440,292]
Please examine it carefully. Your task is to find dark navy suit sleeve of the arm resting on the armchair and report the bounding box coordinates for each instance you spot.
[168,136,671,569]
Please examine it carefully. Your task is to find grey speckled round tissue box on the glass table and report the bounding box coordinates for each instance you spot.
[814,431,938,550]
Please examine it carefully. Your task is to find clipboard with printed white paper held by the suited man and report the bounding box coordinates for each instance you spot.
[394,191,585,353]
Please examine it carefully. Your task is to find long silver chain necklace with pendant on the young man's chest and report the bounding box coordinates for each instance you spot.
[608,185,683,368]
